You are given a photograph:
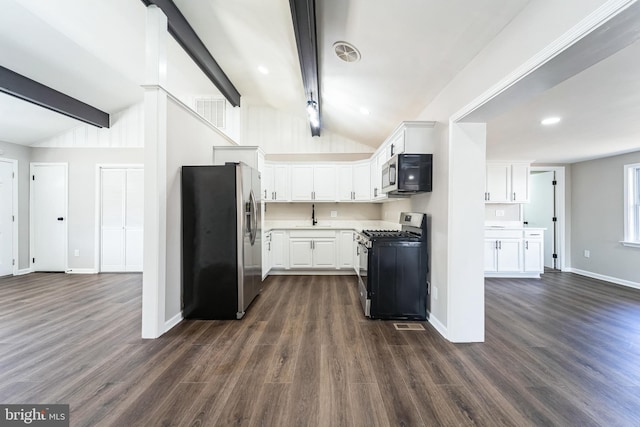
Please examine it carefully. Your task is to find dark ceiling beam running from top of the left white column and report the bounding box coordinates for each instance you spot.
[142,0,240,107]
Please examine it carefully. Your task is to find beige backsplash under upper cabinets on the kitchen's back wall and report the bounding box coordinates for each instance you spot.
[265,203,382,221]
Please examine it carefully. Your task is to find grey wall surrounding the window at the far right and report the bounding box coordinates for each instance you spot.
[571,151,640,287]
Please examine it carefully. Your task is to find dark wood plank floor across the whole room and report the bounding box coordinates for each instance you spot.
[0,273,640,427]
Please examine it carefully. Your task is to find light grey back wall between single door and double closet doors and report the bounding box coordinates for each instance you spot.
[27,148,144,272]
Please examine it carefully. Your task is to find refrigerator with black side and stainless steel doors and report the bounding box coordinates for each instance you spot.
[182,163,262,319]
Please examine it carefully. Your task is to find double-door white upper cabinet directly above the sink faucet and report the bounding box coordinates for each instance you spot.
[291,165,337,202]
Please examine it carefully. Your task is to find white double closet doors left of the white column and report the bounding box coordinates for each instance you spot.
[100,167,144,272]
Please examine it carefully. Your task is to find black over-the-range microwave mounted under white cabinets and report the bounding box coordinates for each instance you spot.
[382,154,433,196]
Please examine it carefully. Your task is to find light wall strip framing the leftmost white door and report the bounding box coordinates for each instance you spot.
[0,141,31,270]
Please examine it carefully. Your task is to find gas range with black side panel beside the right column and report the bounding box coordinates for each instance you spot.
[356,212,429,320]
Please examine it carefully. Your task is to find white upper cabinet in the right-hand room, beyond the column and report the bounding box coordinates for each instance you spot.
[484,162,530,203]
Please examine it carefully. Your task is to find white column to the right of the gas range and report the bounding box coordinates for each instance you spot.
[447,123,486,342]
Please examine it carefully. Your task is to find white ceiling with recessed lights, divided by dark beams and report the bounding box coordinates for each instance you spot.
[0,0,640,162]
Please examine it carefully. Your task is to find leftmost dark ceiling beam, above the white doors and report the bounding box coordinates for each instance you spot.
[0,66,109,128]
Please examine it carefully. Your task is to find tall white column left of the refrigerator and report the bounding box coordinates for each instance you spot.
[142,5,169,338]
